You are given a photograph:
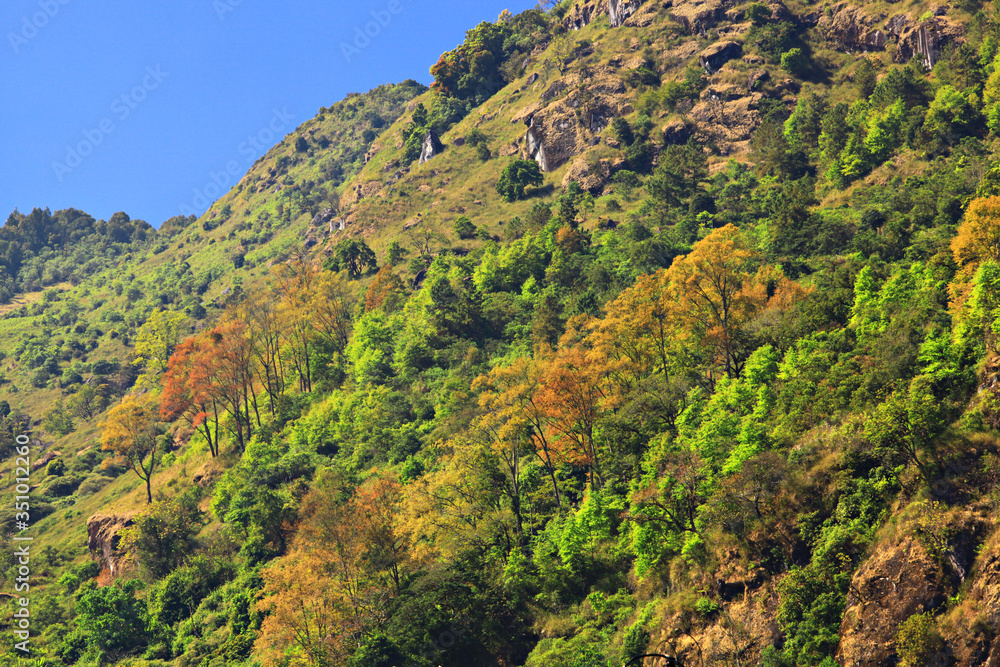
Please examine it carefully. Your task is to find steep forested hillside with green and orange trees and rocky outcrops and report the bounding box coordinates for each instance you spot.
[0,0,1000,667]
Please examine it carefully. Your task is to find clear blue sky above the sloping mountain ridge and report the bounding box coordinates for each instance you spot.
[0,0,535,226]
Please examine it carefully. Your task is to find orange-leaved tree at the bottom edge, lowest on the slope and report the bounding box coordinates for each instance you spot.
[255,474,410,667]
